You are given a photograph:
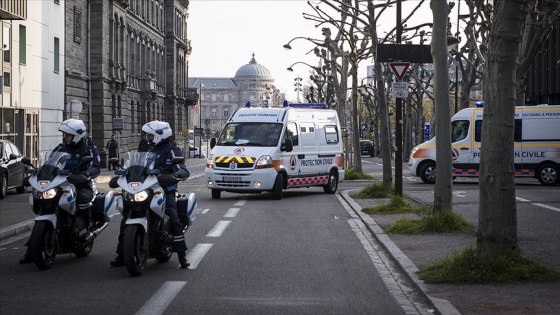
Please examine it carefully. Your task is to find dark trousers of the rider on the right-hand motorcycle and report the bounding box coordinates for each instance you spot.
[117,191,187,255]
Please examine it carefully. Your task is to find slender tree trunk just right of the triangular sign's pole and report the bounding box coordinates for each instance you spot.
[430,0,453,212]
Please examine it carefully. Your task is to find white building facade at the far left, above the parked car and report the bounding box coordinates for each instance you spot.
[0,0,66,163]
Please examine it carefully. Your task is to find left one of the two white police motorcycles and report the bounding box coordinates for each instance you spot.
[22,152,115,270]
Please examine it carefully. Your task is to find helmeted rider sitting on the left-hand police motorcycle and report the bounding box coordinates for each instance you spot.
[19,118,101,264]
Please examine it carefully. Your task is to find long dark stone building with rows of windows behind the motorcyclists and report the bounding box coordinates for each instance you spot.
[65,0,195,160]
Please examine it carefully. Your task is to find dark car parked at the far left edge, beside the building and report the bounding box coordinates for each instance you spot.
[0,140,27,199]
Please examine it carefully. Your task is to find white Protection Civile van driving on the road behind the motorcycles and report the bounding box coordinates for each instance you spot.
[205,104,344,200]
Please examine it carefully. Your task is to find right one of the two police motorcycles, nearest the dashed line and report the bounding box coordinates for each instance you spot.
[109,152,196,276]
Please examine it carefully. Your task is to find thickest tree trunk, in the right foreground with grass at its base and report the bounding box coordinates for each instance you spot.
[477,0,530,256]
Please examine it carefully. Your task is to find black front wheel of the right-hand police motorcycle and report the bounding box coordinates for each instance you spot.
[123,224,148,276]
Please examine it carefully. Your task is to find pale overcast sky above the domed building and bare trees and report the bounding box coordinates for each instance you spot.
[187,0,456,100]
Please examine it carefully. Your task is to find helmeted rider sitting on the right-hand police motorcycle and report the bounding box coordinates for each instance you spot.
[111,120,190,269]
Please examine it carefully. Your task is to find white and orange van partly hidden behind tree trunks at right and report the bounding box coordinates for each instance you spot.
[408,105,560,186]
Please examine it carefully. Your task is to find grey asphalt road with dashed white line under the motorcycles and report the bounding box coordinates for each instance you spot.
[0,165,429,314]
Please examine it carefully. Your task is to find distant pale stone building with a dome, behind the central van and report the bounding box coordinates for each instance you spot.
[188,53,284,137]
